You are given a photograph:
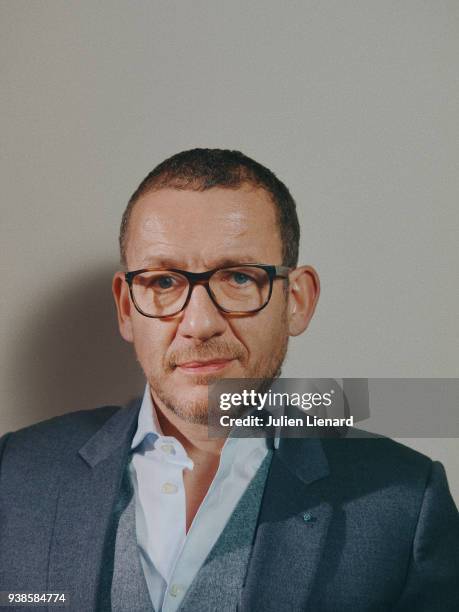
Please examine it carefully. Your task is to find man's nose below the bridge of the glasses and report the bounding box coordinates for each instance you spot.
[177,285,227,342]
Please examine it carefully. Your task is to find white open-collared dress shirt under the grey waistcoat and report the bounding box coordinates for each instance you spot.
[130,384,268,612]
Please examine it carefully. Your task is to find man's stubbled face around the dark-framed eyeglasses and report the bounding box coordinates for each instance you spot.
[114,185,318,423]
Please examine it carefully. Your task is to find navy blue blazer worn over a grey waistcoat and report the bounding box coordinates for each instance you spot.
[0,401,459,612]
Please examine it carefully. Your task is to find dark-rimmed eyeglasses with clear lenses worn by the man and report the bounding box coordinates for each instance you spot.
[125,264,291,319]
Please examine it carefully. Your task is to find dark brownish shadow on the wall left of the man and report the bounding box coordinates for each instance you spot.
[9,266,145,425]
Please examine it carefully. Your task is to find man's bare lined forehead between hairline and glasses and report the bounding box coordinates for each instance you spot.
[127,185,282,270]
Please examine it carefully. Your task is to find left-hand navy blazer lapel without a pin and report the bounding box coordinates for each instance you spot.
[48,401,140,610]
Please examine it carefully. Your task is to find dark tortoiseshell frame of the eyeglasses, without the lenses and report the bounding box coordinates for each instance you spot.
[124,263,293,319]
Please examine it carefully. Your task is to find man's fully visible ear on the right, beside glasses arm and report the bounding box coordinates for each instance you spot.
[288,266,320,336]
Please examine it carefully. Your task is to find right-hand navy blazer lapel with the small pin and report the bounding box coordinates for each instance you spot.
[240,438,332,612]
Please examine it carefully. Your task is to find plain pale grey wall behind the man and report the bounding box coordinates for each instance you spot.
[0,0,459,499]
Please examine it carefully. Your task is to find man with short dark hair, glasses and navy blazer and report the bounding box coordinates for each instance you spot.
[0,149,459,612]
